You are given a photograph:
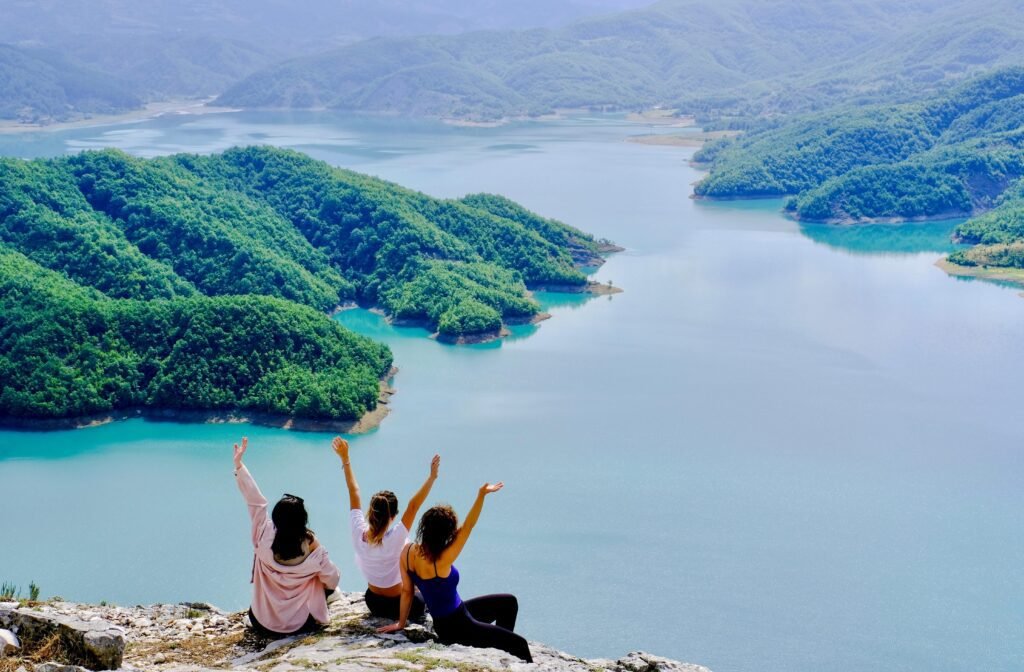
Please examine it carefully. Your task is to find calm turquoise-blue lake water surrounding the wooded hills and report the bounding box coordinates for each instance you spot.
[0,114,1024,672]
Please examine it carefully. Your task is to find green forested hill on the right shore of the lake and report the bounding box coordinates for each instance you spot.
[695,69,1024,267]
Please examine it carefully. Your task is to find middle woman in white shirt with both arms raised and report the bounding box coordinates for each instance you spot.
[333,436,441,621]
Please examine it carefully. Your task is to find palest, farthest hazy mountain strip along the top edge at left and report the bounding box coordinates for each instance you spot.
[0,0,650,53]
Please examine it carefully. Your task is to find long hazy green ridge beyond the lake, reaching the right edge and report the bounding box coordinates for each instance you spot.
[219,0,1024,119]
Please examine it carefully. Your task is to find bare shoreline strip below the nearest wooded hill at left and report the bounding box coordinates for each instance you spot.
[0,367,398,434]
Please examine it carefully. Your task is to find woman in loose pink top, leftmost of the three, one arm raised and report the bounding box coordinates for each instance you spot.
[234,438,341,636]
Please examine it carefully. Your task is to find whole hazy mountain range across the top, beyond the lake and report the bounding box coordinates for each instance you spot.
[0,0,1024,122]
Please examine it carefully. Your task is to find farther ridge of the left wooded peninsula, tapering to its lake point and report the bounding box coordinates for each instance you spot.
[166,149,599,323]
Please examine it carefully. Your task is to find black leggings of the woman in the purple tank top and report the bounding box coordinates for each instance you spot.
[434,594,534,663]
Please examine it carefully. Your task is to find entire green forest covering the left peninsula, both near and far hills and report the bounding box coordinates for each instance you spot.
[0,148,599,419]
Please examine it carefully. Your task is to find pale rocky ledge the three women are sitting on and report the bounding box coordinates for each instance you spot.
[0,593,709,672]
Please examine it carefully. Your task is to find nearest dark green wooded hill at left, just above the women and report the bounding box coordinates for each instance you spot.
[0,249,391,419]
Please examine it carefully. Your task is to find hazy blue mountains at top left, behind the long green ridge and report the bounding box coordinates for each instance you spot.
[0,0,646,120]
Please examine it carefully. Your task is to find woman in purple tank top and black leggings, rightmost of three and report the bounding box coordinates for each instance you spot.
[380,482,534,663]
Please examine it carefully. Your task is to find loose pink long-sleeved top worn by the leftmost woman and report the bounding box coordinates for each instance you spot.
[234,466,341,633]
